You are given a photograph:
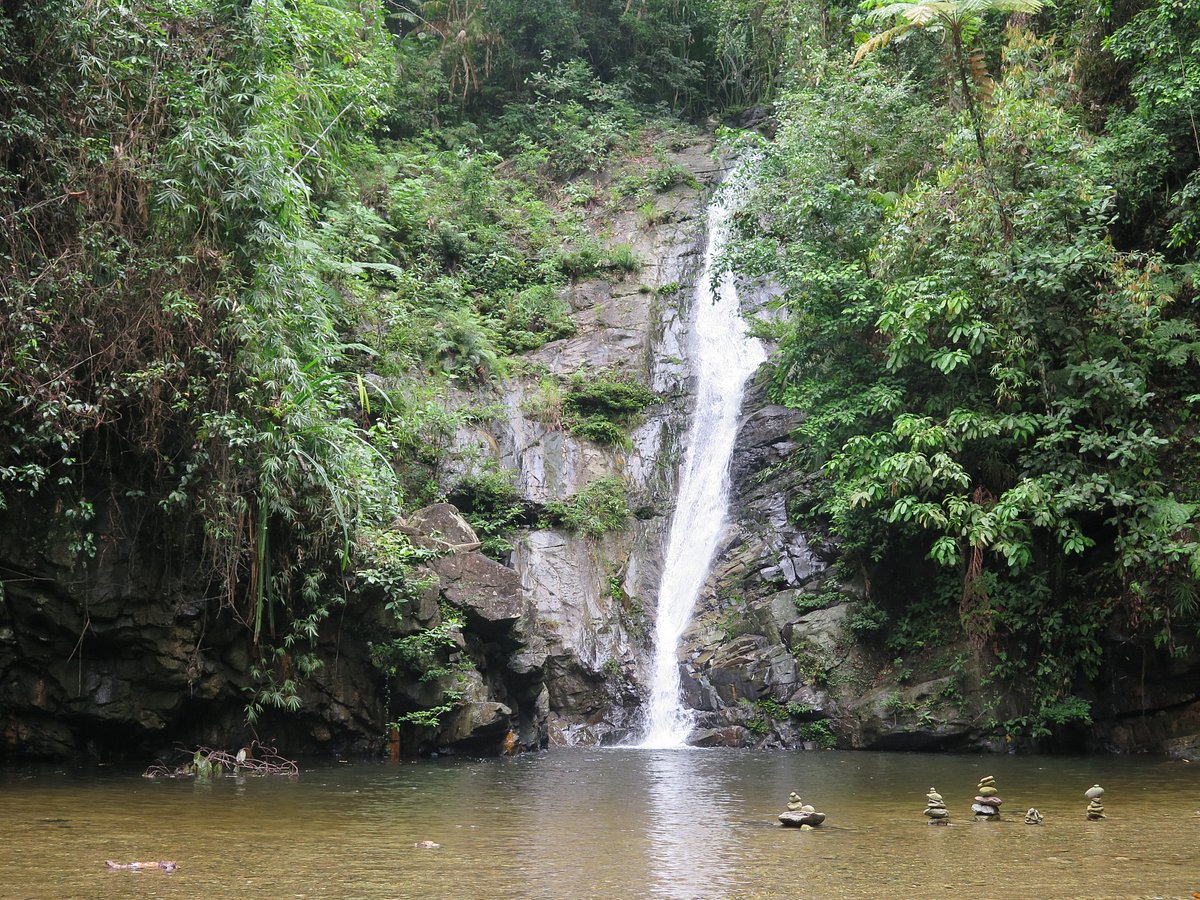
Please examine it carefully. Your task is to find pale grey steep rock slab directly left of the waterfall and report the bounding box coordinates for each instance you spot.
[444,143,721,745]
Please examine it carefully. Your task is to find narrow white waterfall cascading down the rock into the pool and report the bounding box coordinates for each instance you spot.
[641,167,766,748]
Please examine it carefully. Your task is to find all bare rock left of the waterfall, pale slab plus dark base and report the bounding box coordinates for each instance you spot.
[0,142,720,761]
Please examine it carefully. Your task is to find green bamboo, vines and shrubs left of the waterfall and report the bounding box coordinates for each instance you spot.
[0,0,738,734]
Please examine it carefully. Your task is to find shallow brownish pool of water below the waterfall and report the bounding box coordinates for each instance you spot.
[0,749,1200,900]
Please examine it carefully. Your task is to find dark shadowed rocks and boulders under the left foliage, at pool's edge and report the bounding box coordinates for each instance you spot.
[0,494,546,761]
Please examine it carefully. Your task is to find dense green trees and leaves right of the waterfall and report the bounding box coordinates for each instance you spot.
[737,0,1200,734]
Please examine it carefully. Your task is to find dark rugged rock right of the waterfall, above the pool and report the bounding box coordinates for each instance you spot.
[662,374,1200,758]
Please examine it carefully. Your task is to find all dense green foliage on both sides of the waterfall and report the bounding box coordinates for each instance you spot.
[0,0,1200,740]
